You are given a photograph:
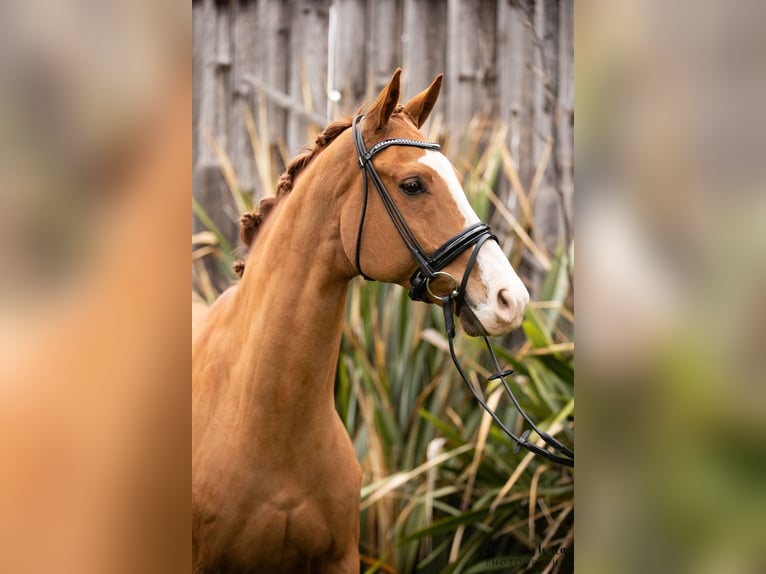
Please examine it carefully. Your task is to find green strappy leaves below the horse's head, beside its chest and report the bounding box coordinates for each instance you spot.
[348,266,574,573]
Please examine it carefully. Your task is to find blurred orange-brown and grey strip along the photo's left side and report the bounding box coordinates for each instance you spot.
[0,1,191,574]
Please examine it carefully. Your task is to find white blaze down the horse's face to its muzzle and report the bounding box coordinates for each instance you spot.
[418,150,529,335]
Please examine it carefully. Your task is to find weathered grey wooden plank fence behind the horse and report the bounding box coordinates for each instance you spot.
[192,0,574,288]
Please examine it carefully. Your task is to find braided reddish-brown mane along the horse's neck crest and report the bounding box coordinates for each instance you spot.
[234,118,351,277]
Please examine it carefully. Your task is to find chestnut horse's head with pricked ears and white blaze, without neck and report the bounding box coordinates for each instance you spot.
[341,70,529,335]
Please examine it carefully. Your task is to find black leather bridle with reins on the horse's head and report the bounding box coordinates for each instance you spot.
[351,114,574,467]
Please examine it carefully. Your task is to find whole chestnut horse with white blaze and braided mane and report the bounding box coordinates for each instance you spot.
[192,70,529,574]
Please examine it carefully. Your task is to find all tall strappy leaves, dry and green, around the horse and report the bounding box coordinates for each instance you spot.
[193,106,574,574]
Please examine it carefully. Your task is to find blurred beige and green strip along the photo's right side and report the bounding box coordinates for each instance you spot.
[576,2,766,574]
